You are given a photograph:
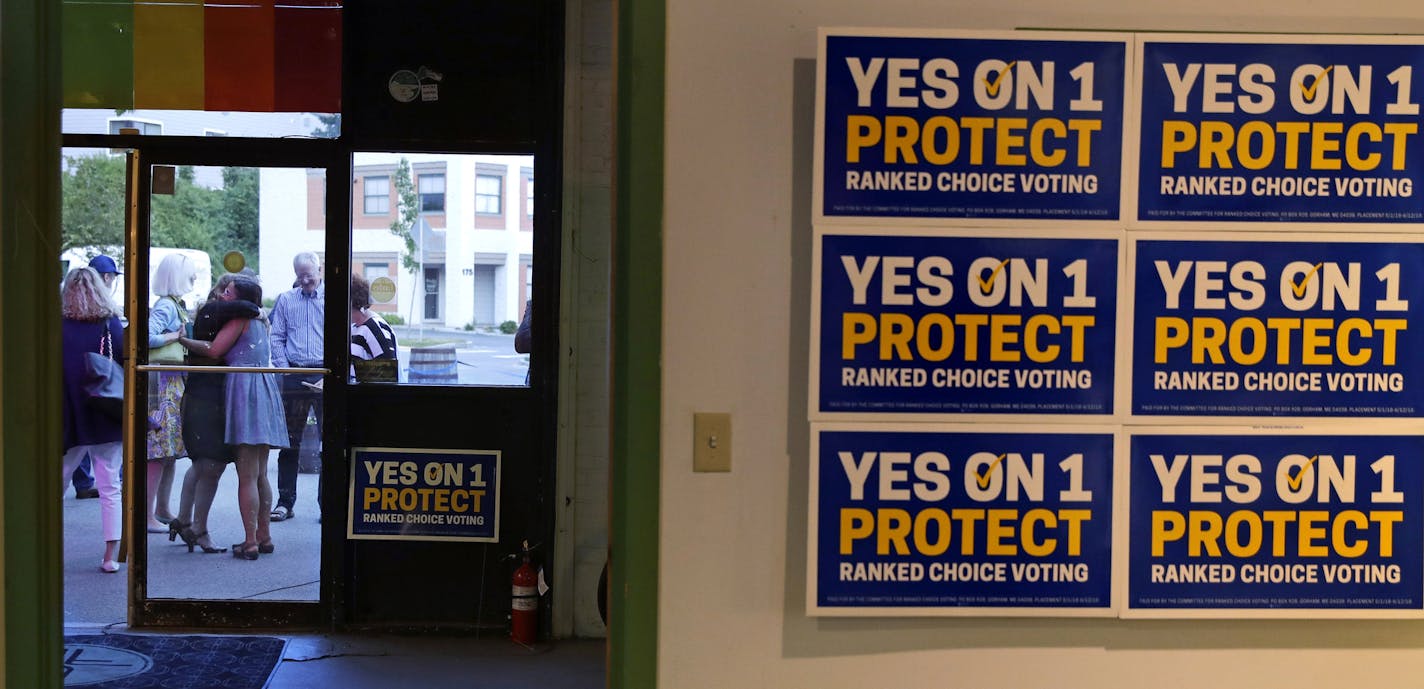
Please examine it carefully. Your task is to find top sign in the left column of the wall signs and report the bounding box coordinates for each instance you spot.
[816,33,1126,221]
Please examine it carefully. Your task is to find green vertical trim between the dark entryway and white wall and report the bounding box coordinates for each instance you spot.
[608,0,666,689]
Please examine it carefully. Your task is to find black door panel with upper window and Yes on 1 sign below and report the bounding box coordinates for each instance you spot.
[338,151,560,629]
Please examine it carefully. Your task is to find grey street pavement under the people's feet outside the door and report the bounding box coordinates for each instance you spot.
[63,451,323,626]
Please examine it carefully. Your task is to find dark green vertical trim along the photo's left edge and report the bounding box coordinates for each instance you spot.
[0,0,64,689]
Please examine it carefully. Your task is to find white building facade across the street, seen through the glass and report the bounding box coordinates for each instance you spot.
[258,154,534,329]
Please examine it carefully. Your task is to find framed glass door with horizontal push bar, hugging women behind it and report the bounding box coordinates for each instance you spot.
[125,145,346,626]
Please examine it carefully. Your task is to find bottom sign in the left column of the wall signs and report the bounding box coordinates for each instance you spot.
[810,427,1114,614]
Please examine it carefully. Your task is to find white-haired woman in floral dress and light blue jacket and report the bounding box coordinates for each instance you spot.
[147,252,198,534]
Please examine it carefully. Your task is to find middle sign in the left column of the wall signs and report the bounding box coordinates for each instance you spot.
[812,233,1119,414]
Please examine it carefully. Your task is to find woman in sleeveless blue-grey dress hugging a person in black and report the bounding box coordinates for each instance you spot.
[178,276,286,559]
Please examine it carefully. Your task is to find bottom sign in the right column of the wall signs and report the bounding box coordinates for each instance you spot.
[1126,431,1424,616]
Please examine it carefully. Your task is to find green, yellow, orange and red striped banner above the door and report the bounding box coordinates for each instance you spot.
[61,0,342,112]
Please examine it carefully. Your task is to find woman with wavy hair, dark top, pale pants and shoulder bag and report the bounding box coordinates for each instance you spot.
[60,266,124,574]
